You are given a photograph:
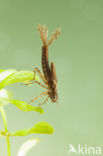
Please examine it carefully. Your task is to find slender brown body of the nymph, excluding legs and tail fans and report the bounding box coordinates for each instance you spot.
[42,45,58,102]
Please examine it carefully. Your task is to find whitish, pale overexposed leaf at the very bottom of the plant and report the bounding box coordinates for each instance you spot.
[17,138,41,156]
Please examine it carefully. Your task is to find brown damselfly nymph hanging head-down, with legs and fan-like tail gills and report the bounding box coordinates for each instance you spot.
[25,25,61,105]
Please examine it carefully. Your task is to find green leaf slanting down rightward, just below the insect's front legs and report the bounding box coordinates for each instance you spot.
[10,100,44,114]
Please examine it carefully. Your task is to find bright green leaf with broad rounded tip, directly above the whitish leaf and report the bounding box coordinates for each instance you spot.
[11,121,54,136]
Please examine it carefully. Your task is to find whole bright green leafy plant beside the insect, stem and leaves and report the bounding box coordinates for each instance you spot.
[0,69,54,156]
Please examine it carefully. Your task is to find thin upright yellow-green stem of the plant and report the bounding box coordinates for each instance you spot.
[0,107,11,156]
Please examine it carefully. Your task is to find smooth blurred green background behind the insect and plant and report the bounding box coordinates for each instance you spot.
[0,0,103,156]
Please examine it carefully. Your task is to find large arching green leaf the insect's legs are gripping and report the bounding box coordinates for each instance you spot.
[0,71,39,89]
